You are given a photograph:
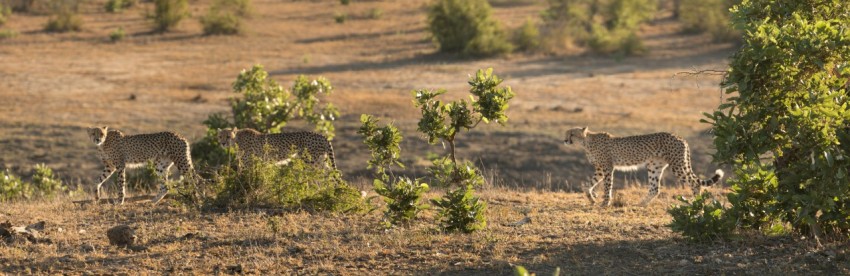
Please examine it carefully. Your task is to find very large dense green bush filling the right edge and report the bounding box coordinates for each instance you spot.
[706,0,850,238]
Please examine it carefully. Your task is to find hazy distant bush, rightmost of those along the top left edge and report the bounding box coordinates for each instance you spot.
[200,0,252,35]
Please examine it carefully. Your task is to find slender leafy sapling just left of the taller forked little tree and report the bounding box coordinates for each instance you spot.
[357,114,428,227]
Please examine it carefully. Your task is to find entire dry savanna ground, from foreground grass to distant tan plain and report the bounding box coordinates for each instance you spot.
[0,0,850,275]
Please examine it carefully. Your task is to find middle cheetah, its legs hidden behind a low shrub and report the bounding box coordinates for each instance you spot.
[218,128,336,170]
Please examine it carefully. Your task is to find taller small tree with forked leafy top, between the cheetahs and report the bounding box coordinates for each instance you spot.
[414,68,514,233]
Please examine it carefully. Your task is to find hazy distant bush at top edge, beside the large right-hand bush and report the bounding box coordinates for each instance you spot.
[677,0,741,41]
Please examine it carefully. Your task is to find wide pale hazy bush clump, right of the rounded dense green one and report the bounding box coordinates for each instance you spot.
[543,0,657,55]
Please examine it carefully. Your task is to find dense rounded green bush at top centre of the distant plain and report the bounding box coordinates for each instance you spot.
[428,0,513,56]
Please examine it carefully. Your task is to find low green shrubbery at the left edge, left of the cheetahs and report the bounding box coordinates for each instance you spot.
[0,164,68,201]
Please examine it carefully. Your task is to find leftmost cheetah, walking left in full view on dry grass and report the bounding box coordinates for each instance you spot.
[88,126,198,204]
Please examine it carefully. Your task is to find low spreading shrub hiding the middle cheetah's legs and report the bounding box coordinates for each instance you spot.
[209,152,366,212]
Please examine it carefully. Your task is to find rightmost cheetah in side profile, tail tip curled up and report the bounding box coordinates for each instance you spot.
[564,127,723,206]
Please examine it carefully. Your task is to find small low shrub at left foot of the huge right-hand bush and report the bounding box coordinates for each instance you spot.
[667,191,735,242]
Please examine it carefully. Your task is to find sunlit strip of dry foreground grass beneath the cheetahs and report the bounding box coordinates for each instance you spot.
[0,189,850,275]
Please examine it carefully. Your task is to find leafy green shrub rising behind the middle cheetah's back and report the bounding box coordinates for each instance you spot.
[192,65,339,167]
